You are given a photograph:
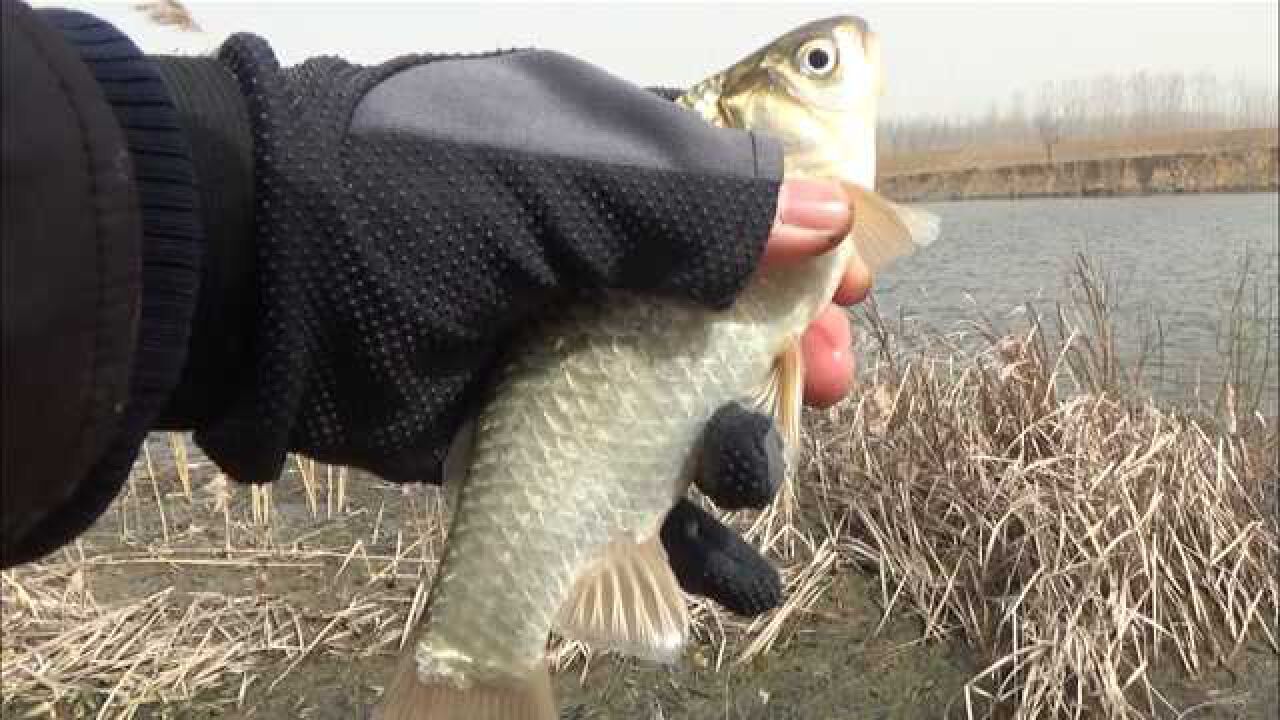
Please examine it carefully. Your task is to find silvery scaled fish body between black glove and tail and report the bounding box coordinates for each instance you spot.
[424,296,781,678]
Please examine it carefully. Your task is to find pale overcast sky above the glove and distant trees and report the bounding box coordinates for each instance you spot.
[32,0,1280,117]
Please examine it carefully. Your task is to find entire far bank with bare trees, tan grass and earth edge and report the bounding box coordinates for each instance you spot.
[877,69,1280,202]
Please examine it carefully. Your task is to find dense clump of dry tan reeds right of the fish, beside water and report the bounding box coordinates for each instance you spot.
[814,254,1280,717]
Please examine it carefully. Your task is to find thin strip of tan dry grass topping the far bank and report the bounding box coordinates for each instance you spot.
[879,128,1277,177]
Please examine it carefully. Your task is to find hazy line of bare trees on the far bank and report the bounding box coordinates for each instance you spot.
[879,70,1280,160]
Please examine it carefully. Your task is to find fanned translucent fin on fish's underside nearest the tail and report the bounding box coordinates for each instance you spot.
[556,533,689,662]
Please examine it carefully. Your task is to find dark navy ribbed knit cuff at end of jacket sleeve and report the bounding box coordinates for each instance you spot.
[26,9,204,555]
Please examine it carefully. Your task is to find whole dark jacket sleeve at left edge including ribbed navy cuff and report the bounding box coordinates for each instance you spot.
[0,0,201,568]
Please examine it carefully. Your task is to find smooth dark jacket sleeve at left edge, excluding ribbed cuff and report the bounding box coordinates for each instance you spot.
[0,0,141,568]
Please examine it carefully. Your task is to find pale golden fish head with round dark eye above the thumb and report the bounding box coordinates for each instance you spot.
[717,15,883,188]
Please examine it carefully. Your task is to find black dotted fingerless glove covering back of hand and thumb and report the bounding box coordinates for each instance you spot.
[154,35,782,491]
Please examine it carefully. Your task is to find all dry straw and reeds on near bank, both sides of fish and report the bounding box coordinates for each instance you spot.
[0,254,1280,719]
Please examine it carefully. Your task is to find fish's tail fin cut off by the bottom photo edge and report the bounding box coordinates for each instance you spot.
[374,651,558,720]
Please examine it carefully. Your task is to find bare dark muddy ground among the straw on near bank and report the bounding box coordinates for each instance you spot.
[4,439,1280,720]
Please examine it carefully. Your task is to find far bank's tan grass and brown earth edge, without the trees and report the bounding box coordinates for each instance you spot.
[877,128,1280,202]
